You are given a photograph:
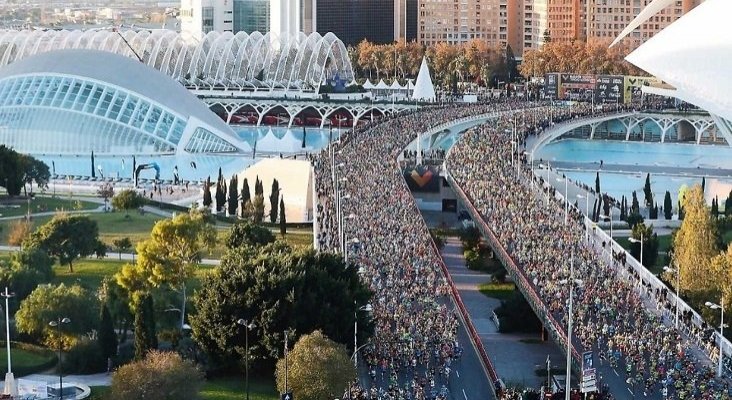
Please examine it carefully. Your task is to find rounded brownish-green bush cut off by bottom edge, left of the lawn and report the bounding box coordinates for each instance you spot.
[110,351,204,400]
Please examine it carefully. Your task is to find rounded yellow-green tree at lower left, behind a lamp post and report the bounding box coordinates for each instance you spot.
[15,283,99,348]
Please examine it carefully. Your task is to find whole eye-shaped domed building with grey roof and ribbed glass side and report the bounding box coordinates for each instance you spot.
[0,50,248,155]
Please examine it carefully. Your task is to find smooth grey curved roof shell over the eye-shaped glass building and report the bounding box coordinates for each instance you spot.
[0,50,234,135]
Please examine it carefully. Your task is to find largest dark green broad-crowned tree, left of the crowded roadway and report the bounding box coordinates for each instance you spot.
[190,242,371,362]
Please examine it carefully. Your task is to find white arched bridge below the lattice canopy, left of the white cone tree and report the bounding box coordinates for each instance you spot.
[199,93,417,129]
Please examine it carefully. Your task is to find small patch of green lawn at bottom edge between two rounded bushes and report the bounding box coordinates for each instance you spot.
[200,376,279,400]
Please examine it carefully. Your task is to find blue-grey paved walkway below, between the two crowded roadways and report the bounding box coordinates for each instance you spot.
[441,237,566,388]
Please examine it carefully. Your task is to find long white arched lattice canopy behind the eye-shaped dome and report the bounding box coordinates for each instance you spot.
[0,29,353,92]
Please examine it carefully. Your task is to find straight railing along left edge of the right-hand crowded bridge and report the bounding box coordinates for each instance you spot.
[445,169,581,368]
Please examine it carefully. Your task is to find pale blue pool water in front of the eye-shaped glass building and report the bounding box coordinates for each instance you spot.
[44,126,345,180]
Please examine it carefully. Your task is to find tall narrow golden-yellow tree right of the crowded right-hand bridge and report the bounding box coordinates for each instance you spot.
[674,185,718,294]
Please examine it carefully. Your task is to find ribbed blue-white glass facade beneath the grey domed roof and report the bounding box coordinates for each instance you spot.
[0,75,236,154]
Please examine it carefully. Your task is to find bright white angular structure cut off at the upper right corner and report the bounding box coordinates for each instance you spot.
[616,0,732,144]
